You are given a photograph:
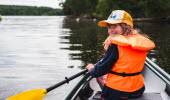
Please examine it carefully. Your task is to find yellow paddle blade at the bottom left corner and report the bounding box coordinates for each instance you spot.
[6,89,47,100]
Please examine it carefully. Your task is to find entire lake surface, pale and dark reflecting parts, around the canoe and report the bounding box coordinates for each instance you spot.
[0,16,170,100]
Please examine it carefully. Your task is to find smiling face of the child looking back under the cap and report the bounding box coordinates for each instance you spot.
[108,24,123,36]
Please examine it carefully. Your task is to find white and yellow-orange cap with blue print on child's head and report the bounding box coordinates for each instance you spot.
[98,10,133,27]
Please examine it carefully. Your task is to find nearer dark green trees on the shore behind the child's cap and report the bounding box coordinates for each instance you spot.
[62,0,170,18]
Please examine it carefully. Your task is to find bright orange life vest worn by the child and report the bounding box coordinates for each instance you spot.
[105,34,155,92]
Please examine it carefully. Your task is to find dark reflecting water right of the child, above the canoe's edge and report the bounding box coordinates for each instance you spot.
[136,23,170,74]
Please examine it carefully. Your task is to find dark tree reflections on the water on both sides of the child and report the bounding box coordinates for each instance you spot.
[61,20,170,73]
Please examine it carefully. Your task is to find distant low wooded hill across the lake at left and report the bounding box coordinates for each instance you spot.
[0,5,63,15]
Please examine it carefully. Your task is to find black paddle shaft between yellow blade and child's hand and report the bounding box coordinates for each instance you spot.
[46,69,88,92]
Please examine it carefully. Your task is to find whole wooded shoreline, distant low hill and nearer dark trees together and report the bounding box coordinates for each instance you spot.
[0,0,170,19]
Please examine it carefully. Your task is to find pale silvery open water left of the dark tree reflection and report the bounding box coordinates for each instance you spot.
[0,16,81,100]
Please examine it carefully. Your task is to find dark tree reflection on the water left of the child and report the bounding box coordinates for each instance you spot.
[61,20,107,66]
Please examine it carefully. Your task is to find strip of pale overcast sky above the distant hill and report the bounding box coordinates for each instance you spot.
[0,0,65,8]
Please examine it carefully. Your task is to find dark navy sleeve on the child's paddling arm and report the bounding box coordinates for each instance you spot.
[90,44,118,77]
